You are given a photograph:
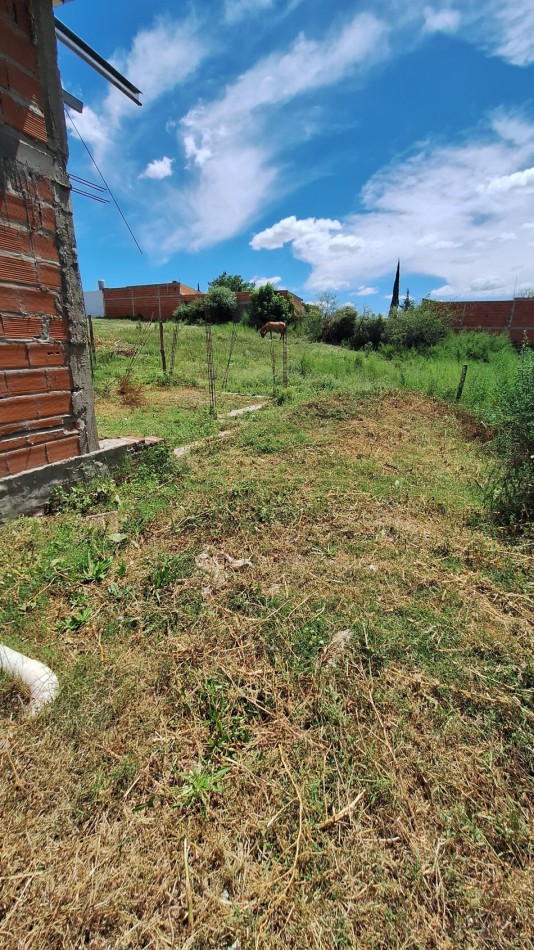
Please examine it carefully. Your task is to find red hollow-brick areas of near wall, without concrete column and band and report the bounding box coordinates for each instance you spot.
[0,0,80,477]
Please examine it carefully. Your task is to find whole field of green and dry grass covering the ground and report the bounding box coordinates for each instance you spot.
[0,324,534,950]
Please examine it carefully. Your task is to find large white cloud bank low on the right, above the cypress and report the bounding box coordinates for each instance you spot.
[251,113,534,297]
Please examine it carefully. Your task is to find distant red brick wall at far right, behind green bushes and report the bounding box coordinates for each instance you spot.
[434,298,534,346]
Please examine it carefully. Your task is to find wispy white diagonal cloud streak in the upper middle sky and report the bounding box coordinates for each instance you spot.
[161,13,387,251]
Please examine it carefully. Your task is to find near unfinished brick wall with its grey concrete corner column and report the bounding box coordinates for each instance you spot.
[0,0,98,477]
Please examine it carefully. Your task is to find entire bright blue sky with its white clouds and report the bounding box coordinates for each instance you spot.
[57,0,534,312]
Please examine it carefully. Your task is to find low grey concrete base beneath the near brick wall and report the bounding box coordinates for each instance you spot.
[0,437,161,523]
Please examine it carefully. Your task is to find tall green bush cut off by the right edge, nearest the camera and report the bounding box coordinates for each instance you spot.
[486,346,534,534]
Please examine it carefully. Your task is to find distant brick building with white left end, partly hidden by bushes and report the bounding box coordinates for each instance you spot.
[83,280,303,320]
